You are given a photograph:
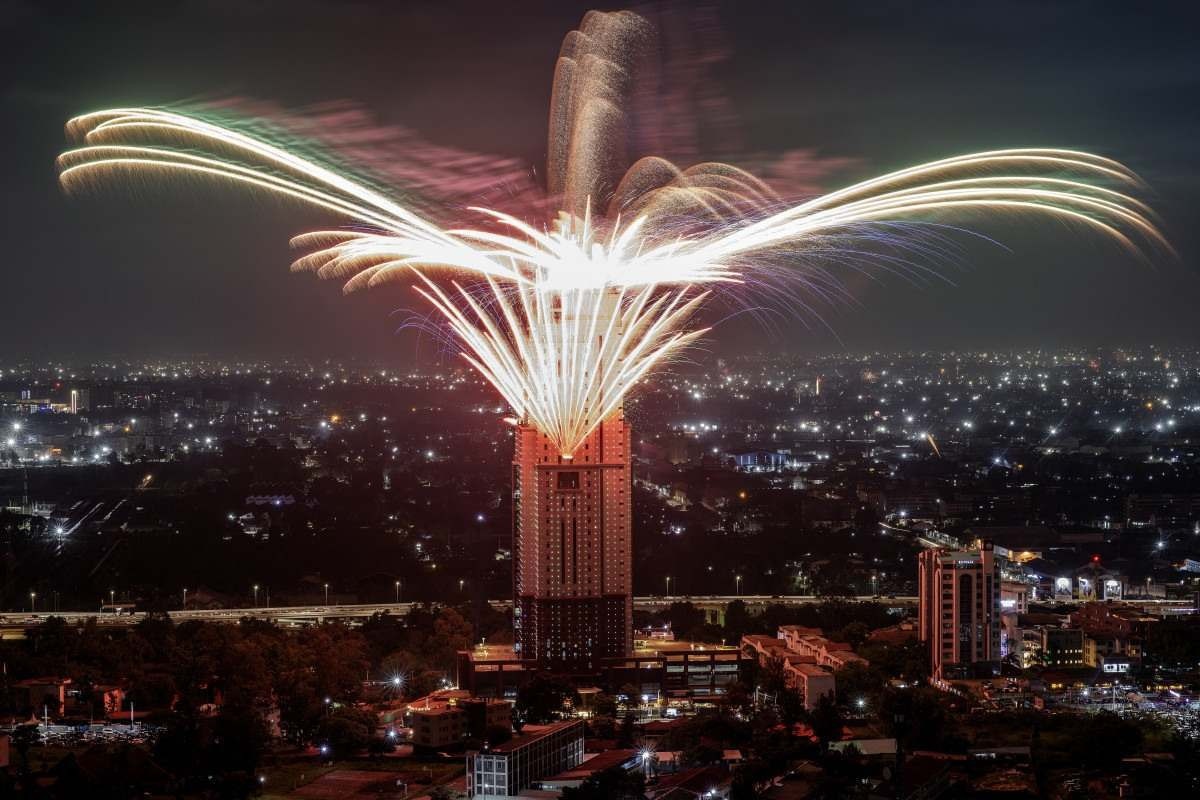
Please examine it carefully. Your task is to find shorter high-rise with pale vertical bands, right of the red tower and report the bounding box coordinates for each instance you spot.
[918,541,1001,678]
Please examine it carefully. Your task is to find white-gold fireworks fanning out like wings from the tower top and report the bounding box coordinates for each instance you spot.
[59,12,1169,457]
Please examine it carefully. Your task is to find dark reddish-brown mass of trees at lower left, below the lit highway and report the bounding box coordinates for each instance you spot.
[0,608,492,794]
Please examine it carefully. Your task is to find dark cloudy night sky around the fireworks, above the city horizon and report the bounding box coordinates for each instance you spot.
[0,0,1200,360]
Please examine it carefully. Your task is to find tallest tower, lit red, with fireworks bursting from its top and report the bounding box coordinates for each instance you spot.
[512,410,634,673]
